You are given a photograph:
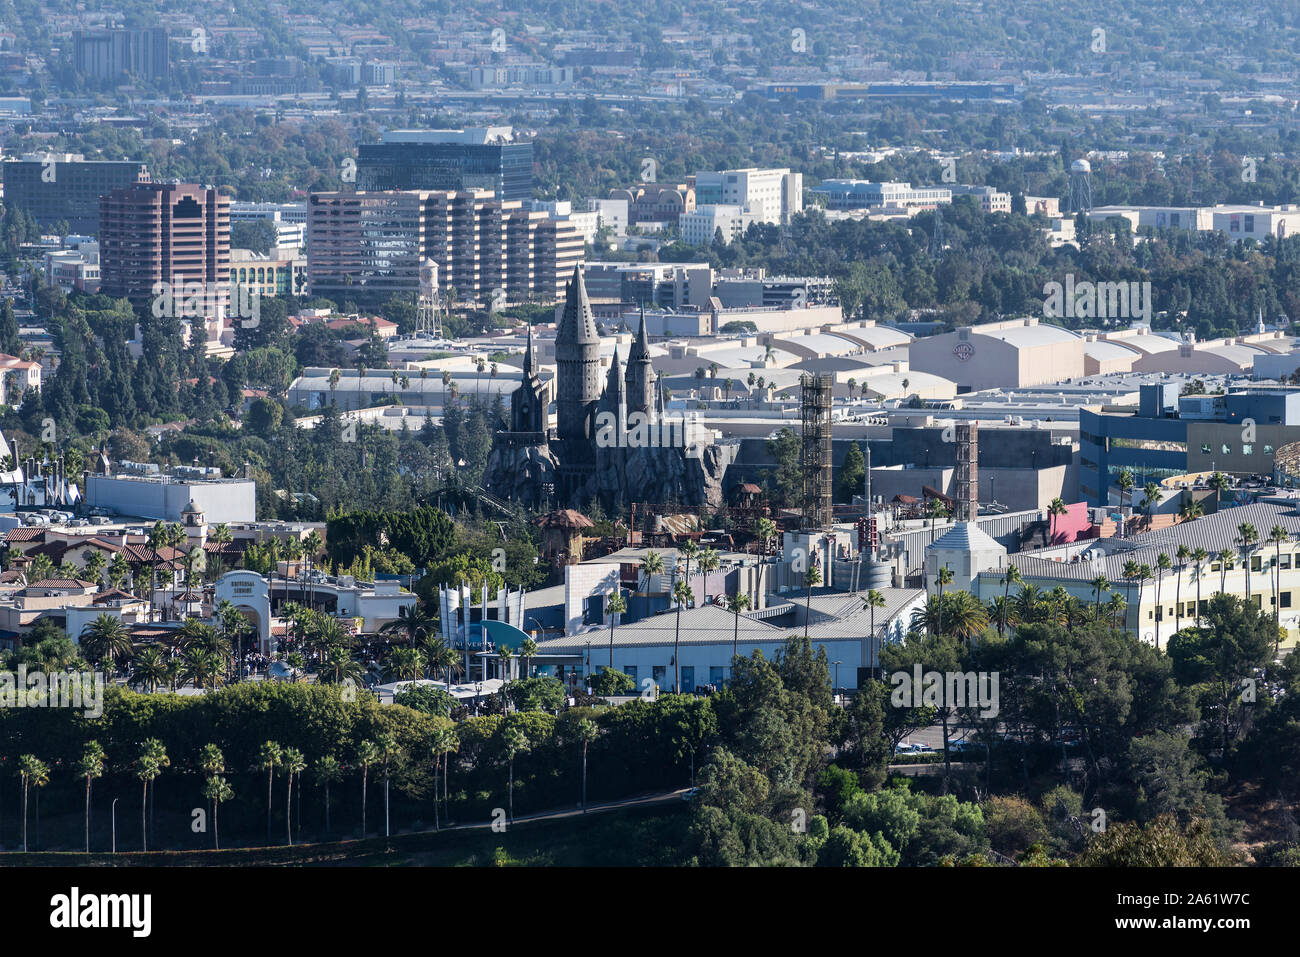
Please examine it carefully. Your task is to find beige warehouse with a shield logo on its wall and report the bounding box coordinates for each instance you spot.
[907,317,1086,391]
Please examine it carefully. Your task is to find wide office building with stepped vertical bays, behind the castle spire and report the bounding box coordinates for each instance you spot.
[307,190,582,304]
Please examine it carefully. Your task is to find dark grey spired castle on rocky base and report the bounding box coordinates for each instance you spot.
[484,268,736,510]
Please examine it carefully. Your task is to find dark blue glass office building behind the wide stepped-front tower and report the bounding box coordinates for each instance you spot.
[356,126,533,200]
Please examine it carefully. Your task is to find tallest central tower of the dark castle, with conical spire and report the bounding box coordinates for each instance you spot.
[555,267,601,445]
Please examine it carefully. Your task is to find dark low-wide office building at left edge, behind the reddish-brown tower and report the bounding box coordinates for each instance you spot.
[3,153,148,234]
